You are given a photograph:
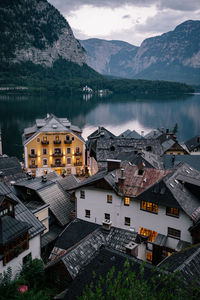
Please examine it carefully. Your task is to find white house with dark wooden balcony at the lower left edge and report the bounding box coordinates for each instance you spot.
[0,182,45,276]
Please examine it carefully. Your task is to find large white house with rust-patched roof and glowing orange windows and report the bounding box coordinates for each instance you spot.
[69,160,200,264]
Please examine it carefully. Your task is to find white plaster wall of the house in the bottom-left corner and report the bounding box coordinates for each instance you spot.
[0,234,40,277]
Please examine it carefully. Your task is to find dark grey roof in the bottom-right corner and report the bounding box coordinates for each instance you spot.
[159,244,200,285]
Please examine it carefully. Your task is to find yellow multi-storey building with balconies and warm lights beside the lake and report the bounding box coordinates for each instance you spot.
[23,115,85,176]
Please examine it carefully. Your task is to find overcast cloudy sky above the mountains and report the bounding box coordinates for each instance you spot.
[48,0,200,46]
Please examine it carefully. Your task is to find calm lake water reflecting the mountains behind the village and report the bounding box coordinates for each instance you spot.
[0,94,200,160]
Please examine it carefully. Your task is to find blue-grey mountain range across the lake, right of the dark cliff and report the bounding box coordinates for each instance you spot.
[80,20,200,84]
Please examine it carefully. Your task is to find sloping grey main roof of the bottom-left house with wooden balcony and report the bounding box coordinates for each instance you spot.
[0,182,45,238]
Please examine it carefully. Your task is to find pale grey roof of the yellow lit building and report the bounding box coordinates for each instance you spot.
[23,114,85,144]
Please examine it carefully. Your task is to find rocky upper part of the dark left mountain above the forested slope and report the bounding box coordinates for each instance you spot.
[0,0,87,67]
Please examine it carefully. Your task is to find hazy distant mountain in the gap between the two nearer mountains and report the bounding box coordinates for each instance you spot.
[80,39,138,77]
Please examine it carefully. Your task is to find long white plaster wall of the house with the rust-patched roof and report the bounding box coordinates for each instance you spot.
[76,187,192,243]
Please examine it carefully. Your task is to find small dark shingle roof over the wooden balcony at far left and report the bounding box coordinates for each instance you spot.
[0,216,32,245]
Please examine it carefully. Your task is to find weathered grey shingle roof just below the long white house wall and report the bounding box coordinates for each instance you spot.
[52,228,137,278]
